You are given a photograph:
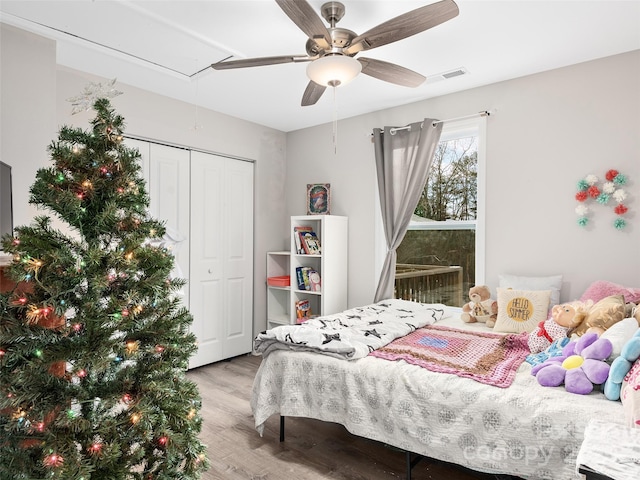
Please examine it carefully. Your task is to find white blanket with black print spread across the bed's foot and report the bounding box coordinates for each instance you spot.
[254,299,448,360]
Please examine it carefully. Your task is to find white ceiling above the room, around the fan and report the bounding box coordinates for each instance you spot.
[0,0,640,132]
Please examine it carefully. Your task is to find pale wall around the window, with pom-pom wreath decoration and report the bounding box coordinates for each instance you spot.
[286,51,640,306]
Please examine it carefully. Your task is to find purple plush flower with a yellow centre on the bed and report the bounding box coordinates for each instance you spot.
[531,333,613,395]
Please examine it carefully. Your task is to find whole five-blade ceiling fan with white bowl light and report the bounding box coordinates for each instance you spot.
[211,0,458,107]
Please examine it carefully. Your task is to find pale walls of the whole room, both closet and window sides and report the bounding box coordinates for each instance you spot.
[6,19,640,322]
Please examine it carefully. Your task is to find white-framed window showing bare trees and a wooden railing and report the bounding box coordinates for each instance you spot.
[395,118,485,307]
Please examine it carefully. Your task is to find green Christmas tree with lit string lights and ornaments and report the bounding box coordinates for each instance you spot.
[0,98,207,480]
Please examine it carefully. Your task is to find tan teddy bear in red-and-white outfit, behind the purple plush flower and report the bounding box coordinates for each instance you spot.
[528,301,592,353]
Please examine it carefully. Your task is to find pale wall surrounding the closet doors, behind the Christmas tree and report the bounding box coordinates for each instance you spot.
[0,24,289,331]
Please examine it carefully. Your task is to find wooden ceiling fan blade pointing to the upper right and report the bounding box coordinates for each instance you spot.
[343,0,459,55]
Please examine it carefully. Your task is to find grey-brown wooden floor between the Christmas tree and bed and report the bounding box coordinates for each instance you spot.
[188,355,516,480]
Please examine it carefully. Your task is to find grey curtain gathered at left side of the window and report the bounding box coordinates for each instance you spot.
[373,118,442,302]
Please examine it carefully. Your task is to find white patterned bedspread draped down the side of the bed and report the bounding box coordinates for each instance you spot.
[251,301,624,480]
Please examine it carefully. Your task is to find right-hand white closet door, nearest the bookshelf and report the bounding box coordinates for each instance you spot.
[189,152,253,368]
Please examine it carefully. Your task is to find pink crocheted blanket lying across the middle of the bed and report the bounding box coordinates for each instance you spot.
[369,326,530,388]
